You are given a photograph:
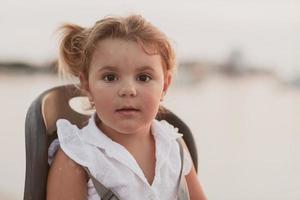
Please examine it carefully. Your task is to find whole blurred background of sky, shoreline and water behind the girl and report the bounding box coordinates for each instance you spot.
[0,0,300,200]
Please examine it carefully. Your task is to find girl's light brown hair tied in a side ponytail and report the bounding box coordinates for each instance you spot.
[58,15,175,79]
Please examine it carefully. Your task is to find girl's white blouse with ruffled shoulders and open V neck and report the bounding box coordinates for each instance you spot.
[48,115,192,200]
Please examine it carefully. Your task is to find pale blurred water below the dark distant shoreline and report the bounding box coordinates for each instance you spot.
[0,73,300,200]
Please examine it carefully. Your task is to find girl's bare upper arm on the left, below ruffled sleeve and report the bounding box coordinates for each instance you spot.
[46,149,88,200]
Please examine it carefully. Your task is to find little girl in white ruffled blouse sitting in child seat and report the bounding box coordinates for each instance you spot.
[47,15,205,200]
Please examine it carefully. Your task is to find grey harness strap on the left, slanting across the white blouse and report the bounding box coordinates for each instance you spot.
[84,167,120,200]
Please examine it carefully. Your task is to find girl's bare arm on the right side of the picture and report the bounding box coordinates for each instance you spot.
[185,166,206,200]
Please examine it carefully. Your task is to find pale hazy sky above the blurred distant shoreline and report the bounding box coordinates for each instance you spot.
[0,0,300,75]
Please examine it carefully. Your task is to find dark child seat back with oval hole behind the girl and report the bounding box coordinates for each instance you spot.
[24,85,198,200]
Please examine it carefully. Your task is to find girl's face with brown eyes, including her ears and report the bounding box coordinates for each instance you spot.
[81,39,171,137]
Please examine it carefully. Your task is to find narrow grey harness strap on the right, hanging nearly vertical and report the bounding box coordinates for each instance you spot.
[176,138,190,200]
